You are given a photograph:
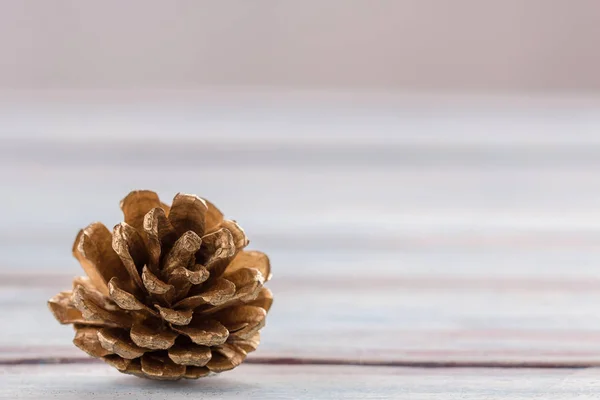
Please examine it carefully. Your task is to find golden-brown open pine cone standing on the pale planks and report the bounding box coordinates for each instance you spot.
[48,191,273,380]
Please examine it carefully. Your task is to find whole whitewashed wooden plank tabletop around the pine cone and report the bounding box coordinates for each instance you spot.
[0,94,600,399]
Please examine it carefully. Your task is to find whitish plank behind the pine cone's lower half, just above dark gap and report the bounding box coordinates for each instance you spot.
[0,275,600,365]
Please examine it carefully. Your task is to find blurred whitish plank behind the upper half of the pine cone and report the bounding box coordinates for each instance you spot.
[0,167,600,277]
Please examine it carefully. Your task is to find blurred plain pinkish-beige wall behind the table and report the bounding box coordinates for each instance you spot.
[0,0,600,91]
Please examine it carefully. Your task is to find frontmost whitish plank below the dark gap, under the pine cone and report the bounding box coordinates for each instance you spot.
[0,364,600,400]
